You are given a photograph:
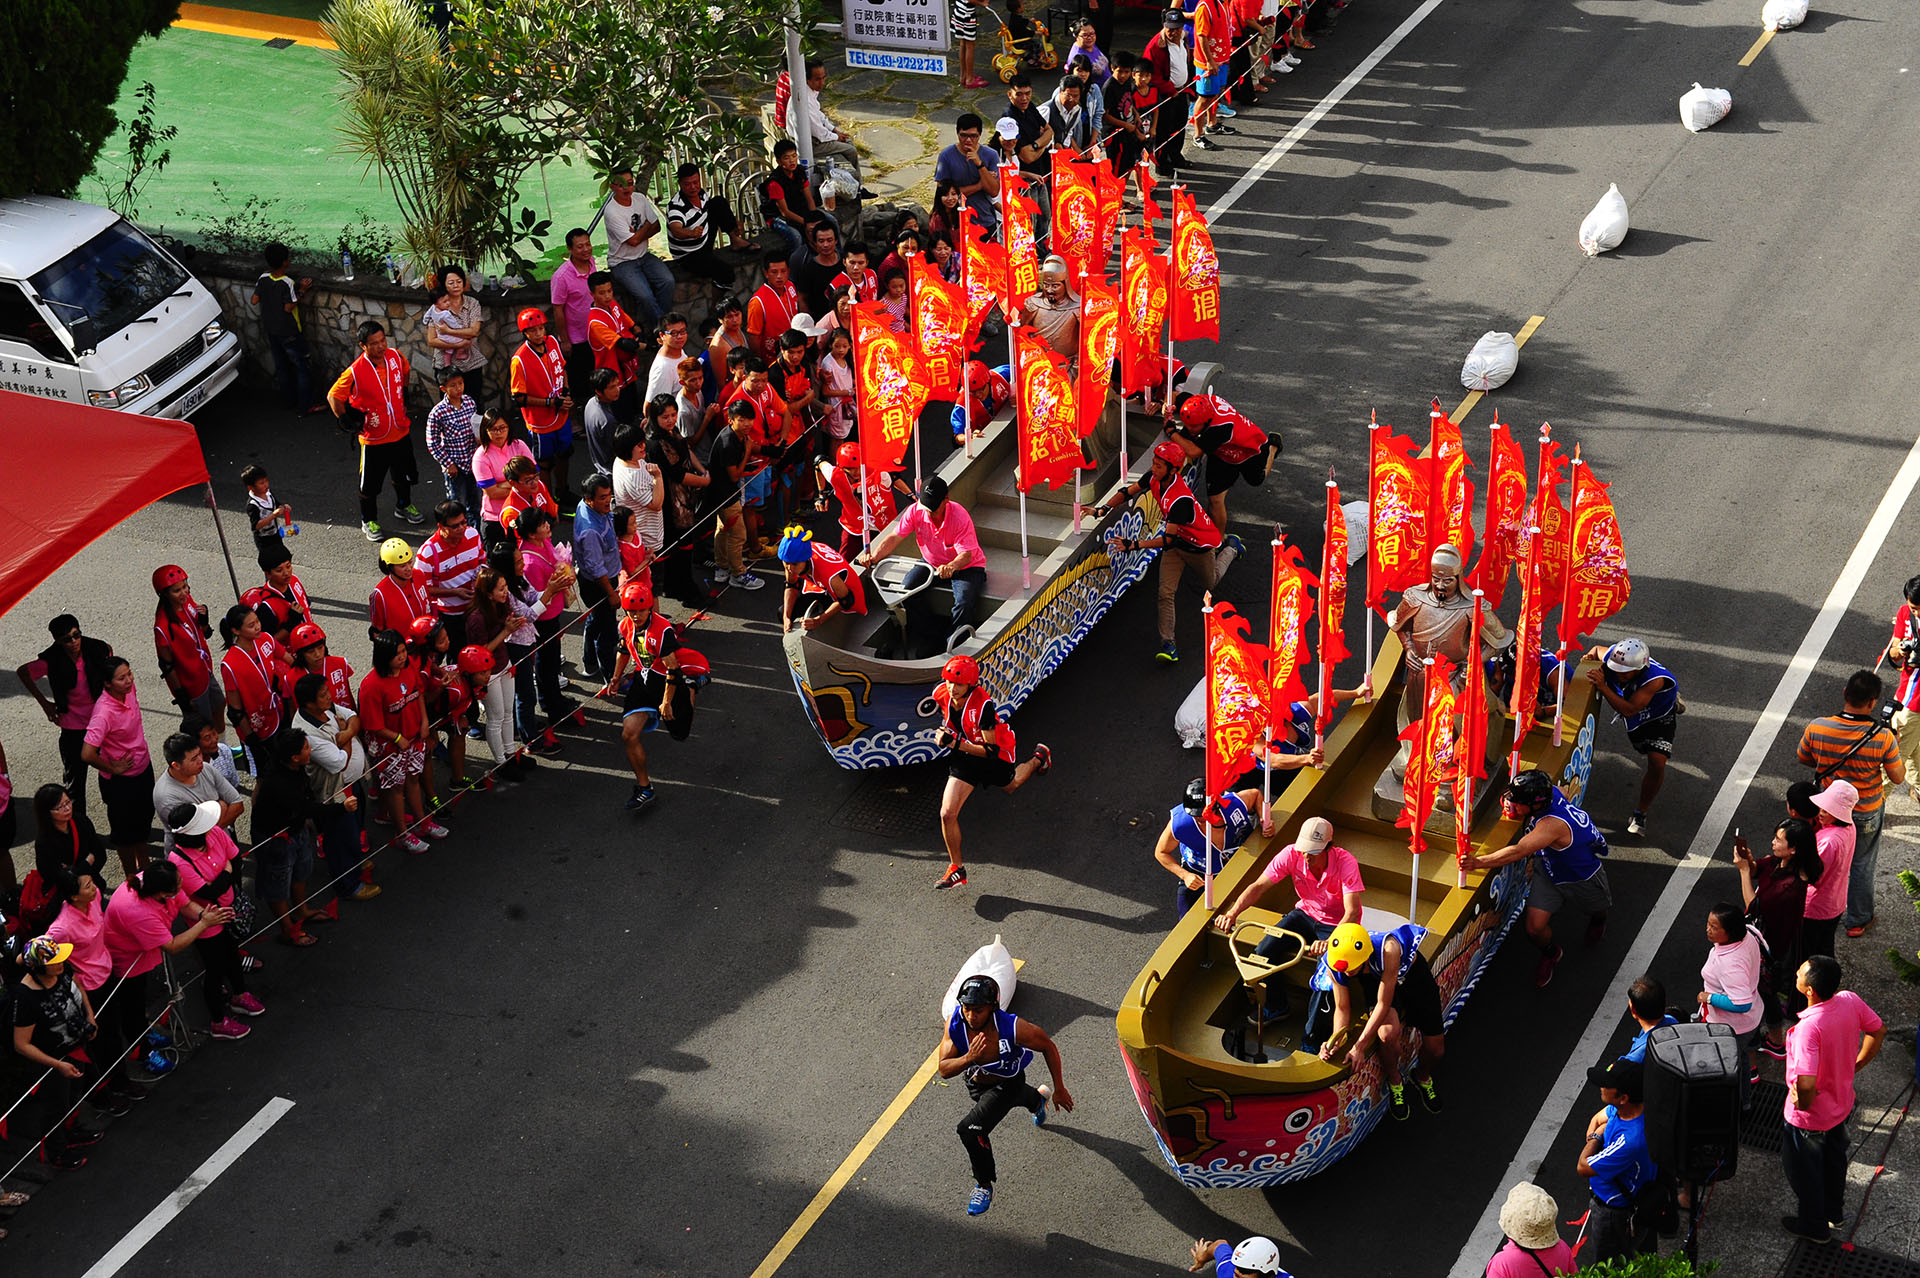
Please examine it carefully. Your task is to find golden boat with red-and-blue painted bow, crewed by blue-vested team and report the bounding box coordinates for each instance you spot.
[1117,635,1596,1188]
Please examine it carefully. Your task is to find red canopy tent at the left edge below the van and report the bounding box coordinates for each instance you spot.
[0,391,240,612]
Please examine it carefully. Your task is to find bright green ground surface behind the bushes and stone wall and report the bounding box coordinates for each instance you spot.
[90,26,597,274]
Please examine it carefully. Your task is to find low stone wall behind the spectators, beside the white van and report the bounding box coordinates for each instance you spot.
[186,253,760,411]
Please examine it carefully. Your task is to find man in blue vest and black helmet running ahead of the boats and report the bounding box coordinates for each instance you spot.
[937,977,1073,1217]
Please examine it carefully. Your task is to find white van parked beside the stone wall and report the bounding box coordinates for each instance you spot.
[0,196,240,416]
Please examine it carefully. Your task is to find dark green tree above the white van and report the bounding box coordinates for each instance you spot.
[0,0,180,198]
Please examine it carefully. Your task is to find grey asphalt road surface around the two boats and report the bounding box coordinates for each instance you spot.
[0,0,1920,1276]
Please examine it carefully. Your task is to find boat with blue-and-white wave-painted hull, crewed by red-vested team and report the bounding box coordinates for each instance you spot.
[783,363,1219,769]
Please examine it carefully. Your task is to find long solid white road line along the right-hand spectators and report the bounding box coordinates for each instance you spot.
[1448,429,1920,1278]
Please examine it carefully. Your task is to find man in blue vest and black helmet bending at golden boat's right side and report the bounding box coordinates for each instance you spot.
[1465,768,1613,986]
